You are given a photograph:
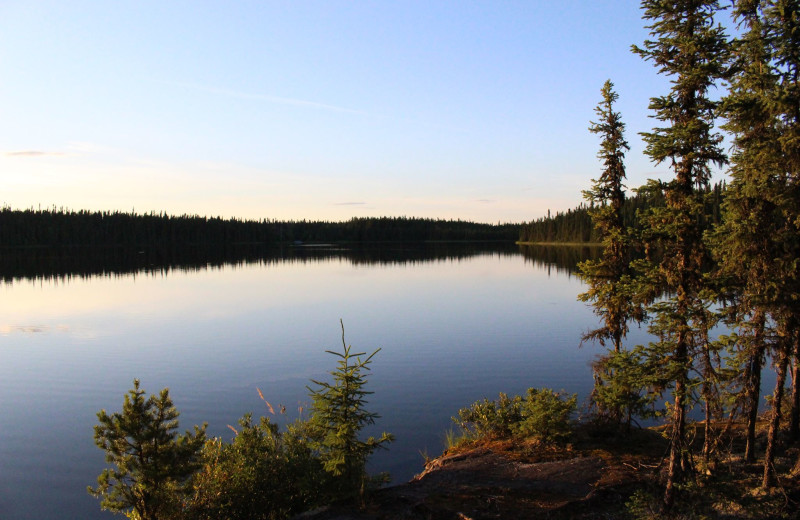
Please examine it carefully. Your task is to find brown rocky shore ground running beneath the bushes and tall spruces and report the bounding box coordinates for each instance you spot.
[299,429,800,520]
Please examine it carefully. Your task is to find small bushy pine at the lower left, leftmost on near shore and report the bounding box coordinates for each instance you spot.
[88,379,206,520]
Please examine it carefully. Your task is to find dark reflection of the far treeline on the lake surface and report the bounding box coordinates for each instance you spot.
[0,242,600,283]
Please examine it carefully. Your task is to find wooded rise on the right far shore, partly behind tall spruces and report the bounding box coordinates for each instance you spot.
[519,181,726,243]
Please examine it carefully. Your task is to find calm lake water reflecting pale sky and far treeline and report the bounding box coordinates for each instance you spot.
[0,245,641,520]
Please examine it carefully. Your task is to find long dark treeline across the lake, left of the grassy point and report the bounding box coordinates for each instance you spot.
[0,207,520,247]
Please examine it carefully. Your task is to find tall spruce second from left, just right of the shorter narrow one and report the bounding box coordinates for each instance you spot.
[633,0,728,508]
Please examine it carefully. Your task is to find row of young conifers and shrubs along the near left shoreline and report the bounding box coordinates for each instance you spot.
[94,327,393,520]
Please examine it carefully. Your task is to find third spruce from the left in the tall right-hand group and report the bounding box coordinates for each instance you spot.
[714,0,782,468]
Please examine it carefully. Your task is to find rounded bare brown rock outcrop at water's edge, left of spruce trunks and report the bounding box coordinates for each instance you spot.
[294,428,664,520]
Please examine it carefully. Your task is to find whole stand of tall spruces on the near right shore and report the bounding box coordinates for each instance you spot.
[564,0,800,516]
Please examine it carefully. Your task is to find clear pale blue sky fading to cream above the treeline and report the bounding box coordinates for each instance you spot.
[0,0,724,223]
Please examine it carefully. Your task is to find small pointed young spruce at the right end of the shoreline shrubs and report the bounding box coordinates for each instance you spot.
[309,324,394,499]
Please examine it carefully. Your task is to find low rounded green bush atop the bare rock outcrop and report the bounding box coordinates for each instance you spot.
[453,388,578,442]
